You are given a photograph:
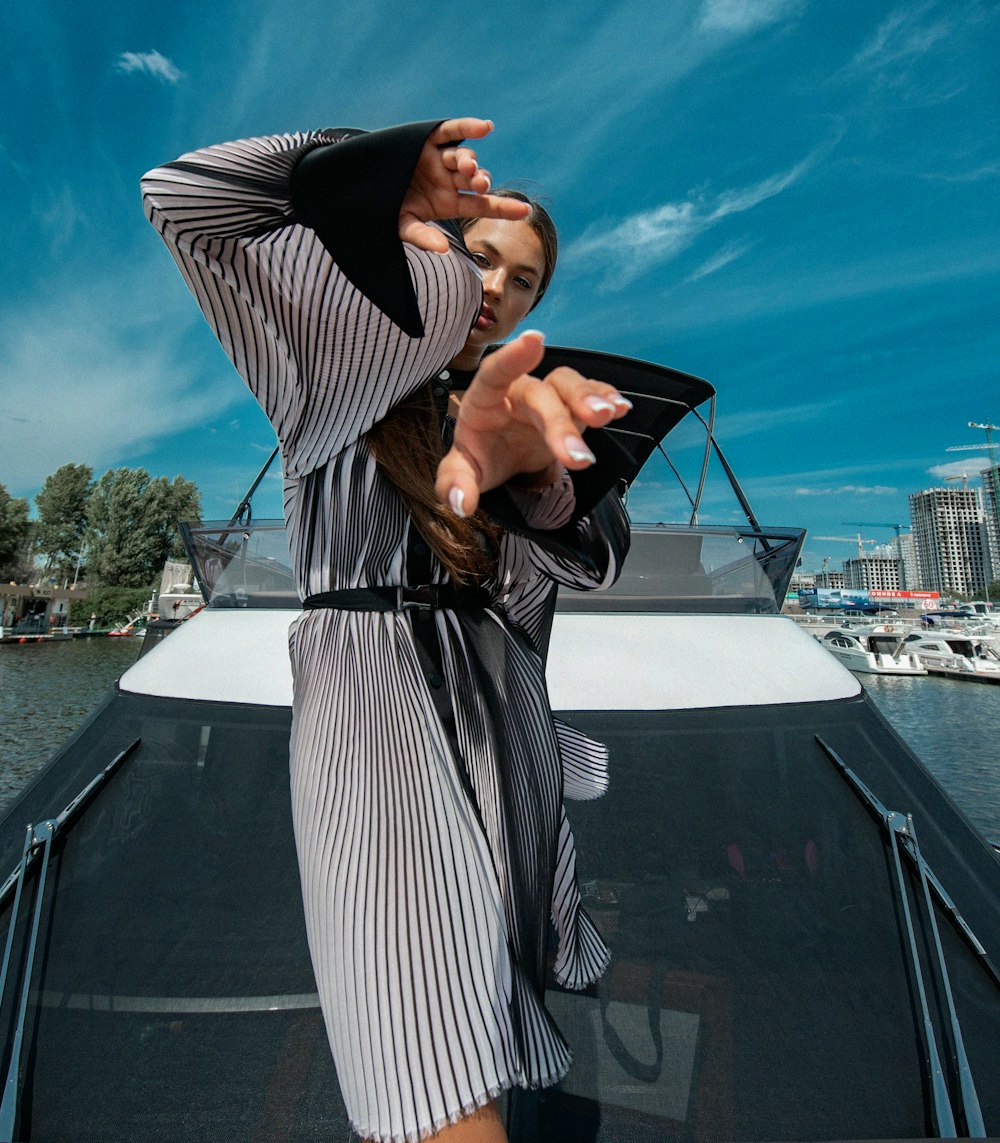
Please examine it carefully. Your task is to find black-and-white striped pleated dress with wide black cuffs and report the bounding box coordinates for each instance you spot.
[143,125,627,1141]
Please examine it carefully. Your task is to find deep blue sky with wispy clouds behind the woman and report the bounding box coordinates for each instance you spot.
[0,0,1000,568]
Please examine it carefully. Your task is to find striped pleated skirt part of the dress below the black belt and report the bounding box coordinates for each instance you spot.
[290,612,608,1143]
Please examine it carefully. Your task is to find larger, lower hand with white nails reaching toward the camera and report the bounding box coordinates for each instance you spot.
[434,330,632,515]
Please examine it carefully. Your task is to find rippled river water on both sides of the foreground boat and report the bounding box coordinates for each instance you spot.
[0,638,1000,840]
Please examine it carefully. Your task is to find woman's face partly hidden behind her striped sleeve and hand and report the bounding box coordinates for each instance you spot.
[451,218,545,369]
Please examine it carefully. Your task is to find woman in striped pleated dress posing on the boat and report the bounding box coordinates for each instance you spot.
[143,119,629,1141]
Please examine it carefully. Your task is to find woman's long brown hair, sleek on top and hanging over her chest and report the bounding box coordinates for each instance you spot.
[368,189,559,584]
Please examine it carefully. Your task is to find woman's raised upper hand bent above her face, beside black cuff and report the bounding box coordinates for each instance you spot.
[399,119,531,254]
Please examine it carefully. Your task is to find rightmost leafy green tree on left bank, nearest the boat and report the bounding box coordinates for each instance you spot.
[86,469,201,588]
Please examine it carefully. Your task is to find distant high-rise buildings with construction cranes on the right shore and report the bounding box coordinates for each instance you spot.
[794,464,1000,599]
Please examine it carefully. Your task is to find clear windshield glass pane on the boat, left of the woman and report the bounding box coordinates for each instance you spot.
[181,520,301,608]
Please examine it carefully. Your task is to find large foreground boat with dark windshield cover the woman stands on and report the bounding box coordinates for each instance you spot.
[0,351,1000,1143]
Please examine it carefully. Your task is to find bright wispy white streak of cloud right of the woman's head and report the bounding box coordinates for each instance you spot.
[566,136,839,289]
